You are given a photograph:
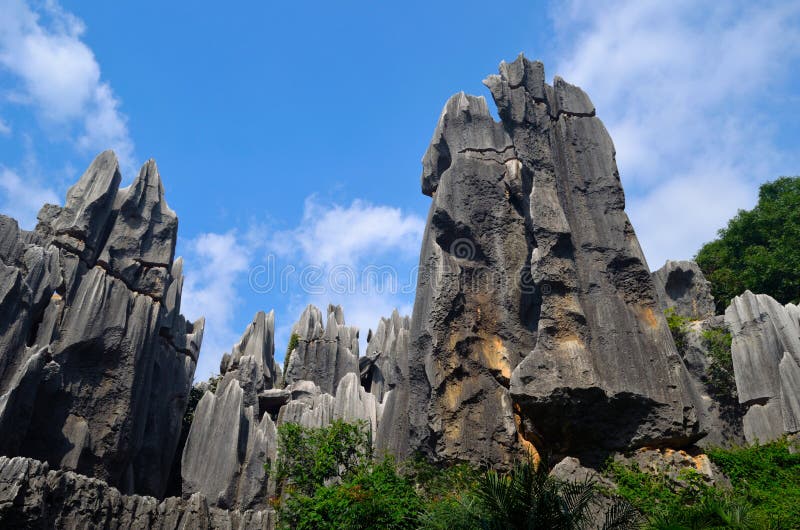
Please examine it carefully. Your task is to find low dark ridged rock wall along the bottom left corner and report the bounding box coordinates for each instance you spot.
[0,457,275,530]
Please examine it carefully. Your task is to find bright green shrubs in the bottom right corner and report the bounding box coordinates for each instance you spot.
[607,441,800,530]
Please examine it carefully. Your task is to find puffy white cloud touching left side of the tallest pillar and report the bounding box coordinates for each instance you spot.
[267,196,425,349]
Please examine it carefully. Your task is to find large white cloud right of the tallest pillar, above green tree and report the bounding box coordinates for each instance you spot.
[553,0,800,268]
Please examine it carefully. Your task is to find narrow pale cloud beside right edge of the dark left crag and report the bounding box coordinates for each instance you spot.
[181,232,251,379]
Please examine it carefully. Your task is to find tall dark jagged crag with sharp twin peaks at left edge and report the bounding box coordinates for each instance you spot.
[0,151,203,496]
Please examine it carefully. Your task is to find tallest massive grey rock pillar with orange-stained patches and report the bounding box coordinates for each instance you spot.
[408,56,699,465]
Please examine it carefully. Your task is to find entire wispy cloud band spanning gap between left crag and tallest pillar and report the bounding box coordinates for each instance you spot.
[181,196,425,379]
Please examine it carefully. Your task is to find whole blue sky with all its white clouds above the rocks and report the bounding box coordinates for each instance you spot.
[0,0,800,378]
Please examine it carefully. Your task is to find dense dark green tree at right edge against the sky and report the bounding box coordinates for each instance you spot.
[695,177,800,313]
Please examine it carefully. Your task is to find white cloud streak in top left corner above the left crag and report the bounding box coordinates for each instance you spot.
[0,0,135,168]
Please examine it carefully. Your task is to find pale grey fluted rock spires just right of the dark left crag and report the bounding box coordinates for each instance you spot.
[181,312,278,509]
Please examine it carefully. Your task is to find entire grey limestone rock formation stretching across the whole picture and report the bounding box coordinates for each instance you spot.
[0,56,800,528]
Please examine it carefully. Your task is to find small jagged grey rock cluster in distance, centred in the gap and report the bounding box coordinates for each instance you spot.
[285,305,358,394]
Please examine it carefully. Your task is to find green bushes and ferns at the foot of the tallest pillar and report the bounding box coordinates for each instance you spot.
[267,421,638,530]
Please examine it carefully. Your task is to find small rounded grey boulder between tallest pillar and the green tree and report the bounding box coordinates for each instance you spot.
[653,260,715,320]
